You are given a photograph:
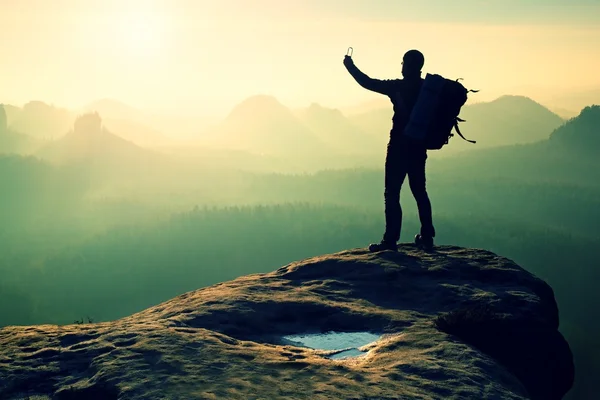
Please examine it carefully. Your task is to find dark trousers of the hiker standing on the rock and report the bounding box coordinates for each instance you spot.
[383,143,435,243]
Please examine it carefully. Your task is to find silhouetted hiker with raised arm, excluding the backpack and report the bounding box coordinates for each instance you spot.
[344,50,435,252]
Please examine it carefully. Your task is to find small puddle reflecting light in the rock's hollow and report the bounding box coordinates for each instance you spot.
[282,332,381,360]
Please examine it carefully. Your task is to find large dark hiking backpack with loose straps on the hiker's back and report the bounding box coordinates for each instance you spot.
[404,74,477,150]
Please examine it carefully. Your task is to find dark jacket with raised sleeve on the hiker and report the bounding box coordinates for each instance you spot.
[344,59,423,150]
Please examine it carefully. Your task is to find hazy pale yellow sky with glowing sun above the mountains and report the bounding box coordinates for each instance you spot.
[0,0,600,115]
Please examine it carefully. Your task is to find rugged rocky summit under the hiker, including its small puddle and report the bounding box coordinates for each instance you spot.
[0,245,574,400]
